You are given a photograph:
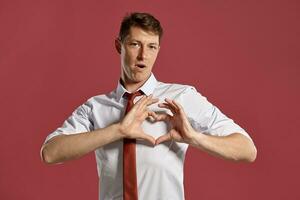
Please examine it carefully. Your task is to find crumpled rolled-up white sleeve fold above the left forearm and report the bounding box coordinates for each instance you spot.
[45,101,93,143]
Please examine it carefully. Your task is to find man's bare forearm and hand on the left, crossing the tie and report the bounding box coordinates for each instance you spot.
[41,95,158,164]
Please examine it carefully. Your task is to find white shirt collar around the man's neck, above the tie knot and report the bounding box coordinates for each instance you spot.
[116,73,157,101]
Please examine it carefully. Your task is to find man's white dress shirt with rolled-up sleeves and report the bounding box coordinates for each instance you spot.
[46,74,251,200]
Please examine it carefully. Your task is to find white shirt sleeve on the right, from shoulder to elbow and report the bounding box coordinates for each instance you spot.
[178,86,251,140]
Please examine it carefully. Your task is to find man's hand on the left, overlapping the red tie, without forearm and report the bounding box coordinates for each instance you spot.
[119,95,158,146]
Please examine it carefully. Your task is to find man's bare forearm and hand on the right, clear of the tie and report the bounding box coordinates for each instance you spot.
[155,99,257,162]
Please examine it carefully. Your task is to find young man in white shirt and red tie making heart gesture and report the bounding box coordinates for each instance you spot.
[41,13,256,200]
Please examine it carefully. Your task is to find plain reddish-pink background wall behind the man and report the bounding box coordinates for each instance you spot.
[0,0,300,200]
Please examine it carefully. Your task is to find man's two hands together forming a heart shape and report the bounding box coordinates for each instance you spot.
[120,95,196,146]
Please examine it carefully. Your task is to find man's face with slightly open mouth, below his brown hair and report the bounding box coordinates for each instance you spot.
[117,27,159,84]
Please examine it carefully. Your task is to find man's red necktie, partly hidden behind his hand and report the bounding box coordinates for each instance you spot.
[123,91,142,200]
